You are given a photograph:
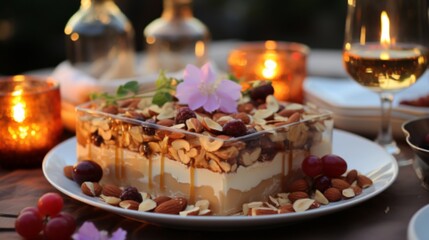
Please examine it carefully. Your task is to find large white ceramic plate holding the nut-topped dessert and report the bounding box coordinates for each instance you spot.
[42,130,398,230]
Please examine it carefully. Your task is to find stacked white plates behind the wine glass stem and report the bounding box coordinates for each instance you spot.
[304,73,429,137]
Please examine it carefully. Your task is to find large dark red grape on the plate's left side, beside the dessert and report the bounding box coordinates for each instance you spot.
[72,160,103,186]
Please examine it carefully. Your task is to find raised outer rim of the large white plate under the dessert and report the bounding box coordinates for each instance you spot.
[42,129,399,231]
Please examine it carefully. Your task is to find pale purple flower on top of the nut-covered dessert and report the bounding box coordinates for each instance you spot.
[176,63,241,113]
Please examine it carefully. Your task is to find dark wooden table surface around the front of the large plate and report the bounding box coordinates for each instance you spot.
[0,133,429,240]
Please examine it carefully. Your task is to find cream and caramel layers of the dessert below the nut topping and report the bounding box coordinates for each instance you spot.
[77,134,331,215]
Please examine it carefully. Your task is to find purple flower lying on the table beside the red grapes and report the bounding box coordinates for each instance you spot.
[72,222,127,240]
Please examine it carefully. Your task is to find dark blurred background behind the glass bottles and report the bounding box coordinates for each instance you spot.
[0,0,347,75]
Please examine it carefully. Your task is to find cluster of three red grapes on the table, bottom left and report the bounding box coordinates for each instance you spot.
[15,192,76,240]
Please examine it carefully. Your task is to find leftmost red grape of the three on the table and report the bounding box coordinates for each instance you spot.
[15,211,43,239]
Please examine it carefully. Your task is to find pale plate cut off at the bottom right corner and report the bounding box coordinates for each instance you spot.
[408,204,429,240]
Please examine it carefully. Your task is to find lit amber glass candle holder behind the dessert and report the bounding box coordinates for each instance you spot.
[228,41,309,103]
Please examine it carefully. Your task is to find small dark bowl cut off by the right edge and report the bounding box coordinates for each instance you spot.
[402,117,429,190]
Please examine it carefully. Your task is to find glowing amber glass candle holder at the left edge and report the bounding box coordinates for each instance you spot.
[0,75,63,168]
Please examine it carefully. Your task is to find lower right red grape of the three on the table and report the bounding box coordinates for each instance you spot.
[44,213,76,240]
